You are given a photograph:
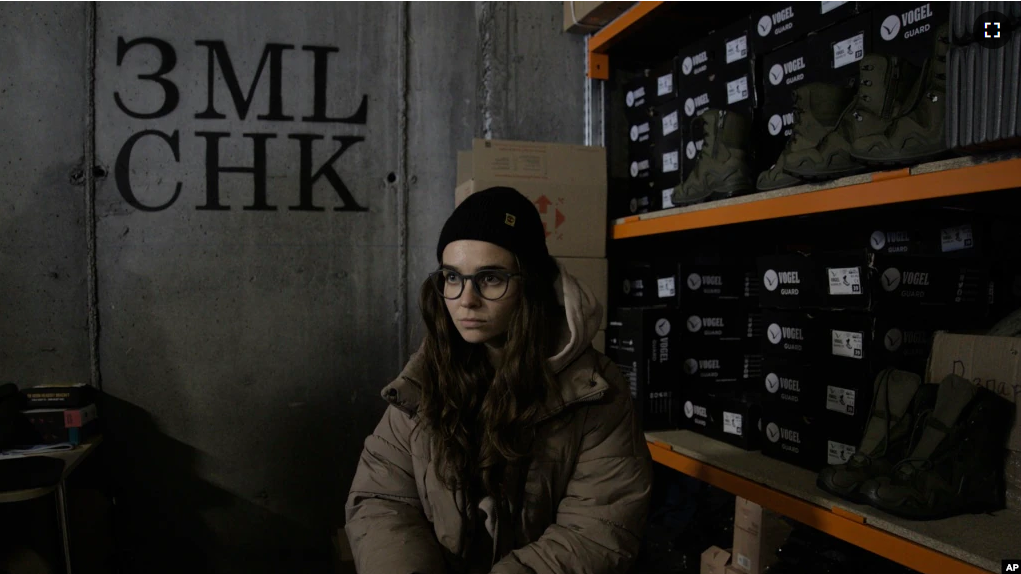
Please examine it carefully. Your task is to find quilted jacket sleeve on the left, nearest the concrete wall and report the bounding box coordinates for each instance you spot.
[344,406,446,574]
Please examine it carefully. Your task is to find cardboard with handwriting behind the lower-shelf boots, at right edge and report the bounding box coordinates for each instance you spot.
[925,332,1021,452]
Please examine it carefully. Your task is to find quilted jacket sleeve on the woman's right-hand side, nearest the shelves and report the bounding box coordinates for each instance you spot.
[492,357,652,574]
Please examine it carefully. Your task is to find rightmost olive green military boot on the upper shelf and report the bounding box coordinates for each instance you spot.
[852,23,950,165]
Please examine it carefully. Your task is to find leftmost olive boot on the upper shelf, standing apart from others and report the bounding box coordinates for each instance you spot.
[674,109,755,205]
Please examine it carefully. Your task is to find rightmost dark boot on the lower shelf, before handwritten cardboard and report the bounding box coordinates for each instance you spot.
[862,375,1014,520]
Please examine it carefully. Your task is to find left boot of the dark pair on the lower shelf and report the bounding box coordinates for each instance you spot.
[816,369,937,505]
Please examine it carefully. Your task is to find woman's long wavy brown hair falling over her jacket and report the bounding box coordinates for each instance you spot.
[419,257,562,499]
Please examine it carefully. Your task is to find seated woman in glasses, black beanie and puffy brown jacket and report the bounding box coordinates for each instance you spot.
[346,188,651,574]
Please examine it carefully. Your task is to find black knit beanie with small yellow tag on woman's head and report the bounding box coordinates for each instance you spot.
[436,187,555,270]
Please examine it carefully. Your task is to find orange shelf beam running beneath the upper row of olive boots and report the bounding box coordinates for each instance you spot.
[613,159,1021,239]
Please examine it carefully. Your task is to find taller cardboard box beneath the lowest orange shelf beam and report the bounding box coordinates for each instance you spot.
[729,496,791,574]
